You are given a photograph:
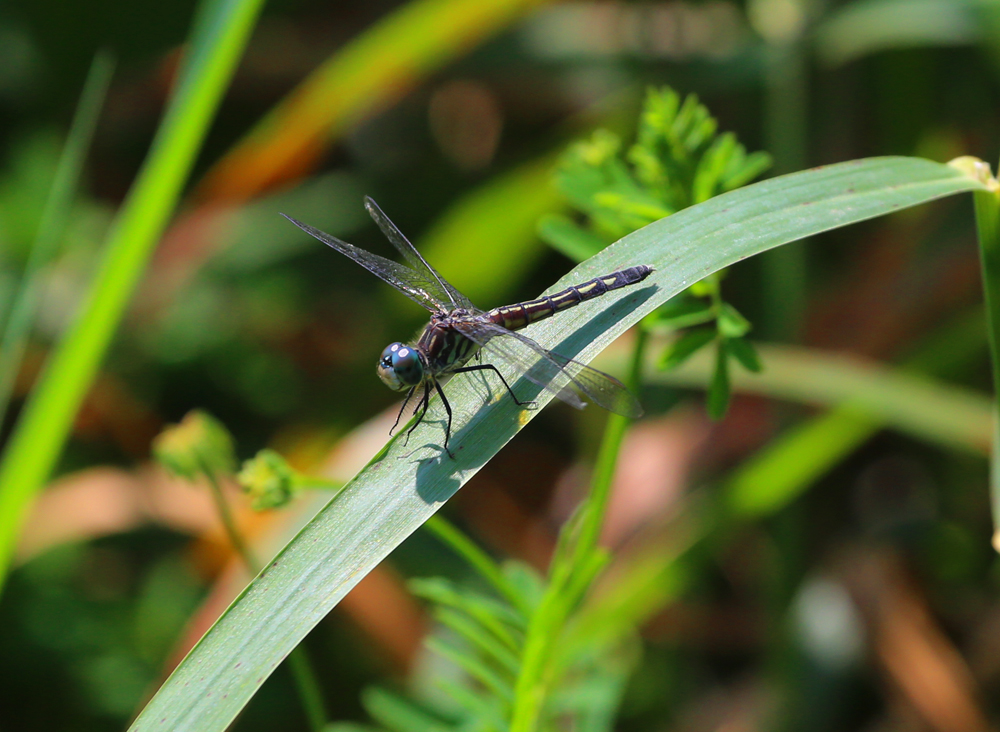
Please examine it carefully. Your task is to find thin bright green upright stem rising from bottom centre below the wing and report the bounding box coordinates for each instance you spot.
[510,326,648,732]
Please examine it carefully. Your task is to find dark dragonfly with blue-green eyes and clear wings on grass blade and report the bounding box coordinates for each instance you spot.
[281,196,654,459]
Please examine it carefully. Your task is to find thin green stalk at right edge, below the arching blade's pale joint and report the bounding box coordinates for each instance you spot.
[973,172,1000,551]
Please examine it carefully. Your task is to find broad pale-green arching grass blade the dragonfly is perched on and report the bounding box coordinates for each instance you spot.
[125,158,985,732]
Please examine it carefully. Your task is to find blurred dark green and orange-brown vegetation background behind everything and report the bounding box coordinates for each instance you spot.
[0,0,1000,732]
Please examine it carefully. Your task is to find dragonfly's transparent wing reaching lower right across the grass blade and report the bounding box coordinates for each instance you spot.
[455,320,642,419]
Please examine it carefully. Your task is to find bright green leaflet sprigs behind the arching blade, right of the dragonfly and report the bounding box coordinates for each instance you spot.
[539,88,771,417]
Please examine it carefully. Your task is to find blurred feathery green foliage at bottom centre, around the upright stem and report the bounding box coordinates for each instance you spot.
[344,518,638,732]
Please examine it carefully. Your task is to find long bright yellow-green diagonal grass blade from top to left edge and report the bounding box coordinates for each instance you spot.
[0,0,262,586]
